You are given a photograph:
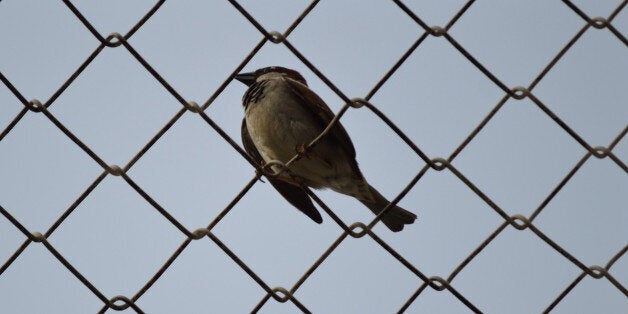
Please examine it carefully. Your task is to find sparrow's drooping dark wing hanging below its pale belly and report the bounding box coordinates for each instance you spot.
[241,119,323,224]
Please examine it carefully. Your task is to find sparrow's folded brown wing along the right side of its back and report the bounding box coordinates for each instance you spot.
[286,79,357,159]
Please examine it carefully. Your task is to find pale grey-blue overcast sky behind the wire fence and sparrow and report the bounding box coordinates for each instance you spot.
[0,0,628,313]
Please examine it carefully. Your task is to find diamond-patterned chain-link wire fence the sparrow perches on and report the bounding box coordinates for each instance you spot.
[0,0,628,313]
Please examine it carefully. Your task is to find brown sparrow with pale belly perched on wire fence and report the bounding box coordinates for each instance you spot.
[235,66,416,232]
